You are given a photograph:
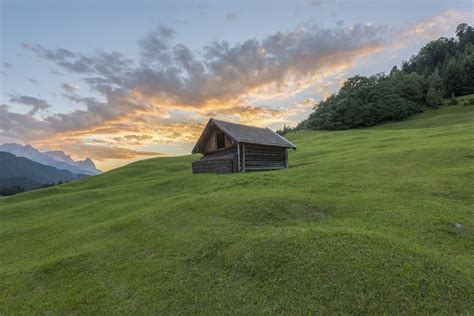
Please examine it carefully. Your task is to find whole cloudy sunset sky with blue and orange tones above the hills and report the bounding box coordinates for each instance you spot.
[0,0,474,170]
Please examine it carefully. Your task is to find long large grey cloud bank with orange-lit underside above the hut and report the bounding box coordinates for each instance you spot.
[25,25,388,107]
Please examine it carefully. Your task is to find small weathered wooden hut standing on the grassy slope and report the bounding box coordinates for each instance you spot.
[192,118,296,173]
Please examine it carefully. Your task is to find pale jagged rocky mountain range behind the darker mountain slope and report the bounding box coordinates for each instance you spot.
[0,144,102,175]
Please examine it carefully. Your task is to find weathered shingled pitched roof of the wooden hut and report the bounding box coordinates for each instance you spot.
[193,118,296,153]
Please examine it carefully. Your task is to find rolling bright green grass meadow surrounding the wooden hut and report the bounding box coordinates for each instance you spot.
[0,100,474,314]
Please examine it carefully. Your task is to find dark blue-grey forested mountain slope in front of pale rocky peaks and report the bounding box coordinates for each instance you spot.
[0,152,87,190]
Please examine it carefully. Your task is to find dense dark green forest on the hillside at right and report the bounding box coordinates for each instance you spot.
[277,23,474,134]
